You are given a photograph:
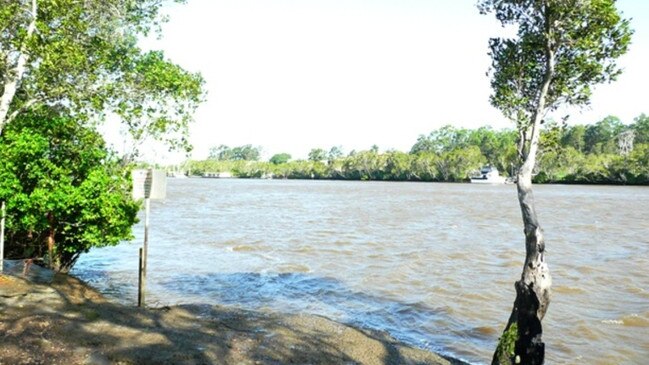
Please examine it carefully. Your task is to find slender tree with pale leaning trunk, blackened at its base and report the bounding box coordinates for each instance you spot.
[478,0,632,364]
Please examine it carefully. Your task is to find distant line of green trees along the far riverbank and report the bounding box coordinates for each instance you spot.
[179,114,649,184]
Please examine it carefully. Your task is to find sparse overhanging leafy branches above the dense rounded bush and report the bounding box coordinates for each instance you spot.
[0,0,204,150]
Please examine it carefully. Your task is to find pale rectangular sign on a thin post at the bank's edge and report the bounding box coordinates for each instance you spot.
[132,169,167,307]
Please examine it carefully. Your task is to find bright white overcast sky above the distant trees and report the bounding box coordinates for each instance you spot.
[120,0,649,163]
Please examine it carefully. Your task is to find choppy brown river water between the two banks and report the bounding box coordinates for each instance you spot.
[73,178,649,364]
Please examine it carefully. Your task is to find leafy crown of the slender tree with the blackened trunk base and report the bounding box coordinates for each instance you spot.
[478,0,632,128]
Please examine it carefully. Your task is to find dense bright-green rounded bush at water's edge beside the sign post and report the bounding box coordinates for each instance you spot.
[0,109,139,271]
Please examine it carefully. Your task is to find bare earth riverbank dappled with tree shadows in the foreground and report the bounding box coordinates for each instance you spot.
[0,266,462,365]
